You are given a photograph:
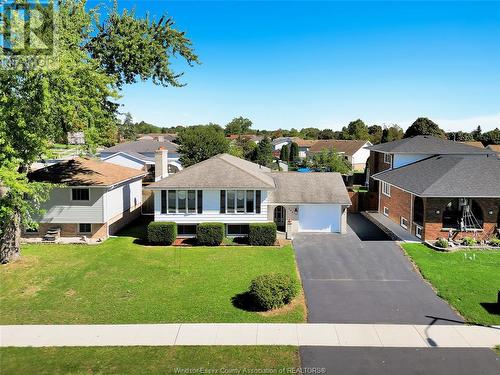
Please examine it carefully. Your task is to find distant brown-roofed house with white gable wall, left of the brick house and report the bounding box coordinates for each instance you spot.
[308,139,372,171]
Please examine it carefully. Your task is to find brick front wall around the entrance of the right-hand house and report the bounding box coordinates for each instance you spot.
[424,198,500,240]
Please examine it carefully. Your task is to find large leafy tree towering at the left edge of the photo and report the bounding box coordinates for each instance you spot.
[0,0,198,263]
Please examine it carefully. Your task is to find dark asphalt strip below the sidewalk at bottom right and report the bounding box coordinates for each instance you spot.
[300,346,500,375]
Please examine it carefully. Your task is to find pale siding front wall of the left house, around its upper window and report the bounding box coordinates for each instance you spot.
[40,187,106,224]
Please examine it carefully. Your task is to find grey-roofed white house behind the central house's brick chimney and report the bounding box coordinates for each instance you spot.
[100,139,182,181]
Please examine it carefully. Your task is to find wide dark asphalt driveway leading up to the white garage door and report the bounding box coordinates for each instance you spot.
[293,214,462,324]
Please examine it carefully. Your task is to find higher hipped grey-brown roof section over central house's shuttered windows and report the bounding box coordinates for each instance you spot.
[149,154,275,190]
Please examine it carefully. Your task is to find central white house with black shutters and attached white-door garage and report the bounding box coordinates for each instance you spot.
[147,154,351,238]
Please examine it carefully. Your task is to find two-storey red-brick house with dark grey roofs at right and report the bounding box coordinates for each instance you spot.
[368,136,500,240]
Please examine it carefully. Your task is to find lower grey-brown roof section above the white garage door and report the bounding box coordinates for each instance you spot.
[269,172,351,205]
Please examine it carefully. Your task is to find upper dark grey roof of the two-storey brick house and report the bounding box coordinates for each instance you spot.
[369,135,491,155]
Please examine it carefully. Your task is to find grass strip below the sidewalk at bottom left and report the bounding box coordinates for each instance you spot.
[0,346,300,375]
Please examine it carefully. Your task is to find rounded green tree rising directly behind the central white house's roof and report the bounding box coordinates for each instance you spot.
[177,124,230,167]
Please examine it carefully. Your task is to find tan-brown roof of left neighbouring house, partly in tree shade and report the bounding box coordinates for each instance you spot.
[28,158,146,186]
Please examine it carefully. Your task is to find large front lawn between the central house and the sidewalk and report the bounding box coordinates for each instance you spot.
[0,231,305,324]
